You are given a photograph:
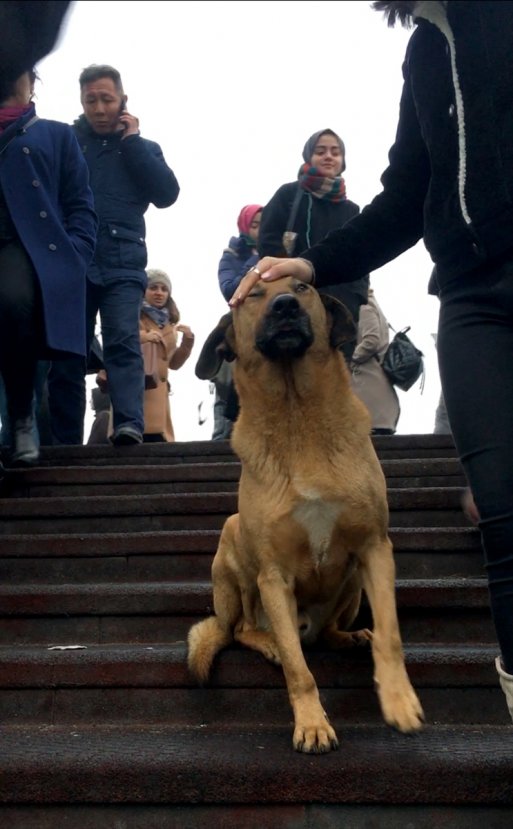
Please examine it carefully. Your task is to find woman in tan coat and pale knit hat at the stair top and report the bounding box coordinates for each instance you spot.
[139,270,194,442]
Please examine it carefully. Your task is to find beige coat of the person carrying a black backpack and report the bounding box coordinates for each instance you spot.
[351,288,401,435]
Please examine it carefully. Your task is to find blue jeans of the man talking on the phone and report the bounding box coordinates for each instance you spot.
[48,279,144,444]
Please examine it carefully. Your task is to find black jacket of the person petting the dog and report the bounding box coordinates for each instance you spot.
[302,0,513,287]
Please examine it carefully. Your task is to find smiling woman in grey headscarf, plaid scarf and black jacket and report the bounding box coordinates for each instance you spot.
[258,129,369,361]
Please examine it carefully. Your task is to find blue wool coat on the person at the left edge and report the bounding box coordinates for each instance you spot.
[0,102,97,355]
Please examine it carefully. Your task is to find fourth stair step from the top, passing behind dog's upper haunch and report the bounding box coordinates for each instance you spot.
[0,527,483,584]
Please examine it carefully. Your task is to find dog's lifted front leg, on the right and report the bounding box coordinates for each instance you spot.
[362,539,423,732]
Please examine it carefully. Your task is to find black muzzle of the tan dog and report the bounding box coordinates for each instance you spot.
[255,294,313,360]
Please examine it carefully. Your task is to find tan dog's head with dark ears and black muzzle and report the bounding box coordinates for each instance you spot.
[196,277,356,380]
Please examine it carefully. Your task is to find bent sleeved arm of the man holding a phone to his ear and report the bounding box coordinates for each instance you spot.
[120,135,180,207]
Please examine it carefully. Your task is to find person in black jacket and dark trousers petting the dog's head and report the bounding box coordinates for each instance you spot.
[231,0,513,716]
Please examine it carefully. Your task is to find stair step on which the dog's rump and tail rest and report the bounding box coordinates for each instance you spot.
[0,642,509,727]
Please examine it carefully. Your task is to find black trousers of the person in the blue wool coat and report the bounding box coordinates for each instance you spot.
[0,240,43,421]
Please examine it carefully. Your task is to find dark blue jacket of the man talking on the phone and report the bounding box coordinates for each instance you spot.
[73,115,180,282]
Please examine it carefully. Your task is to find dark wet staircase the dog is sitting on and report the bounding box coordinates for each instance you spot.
[0,435,513,829]
